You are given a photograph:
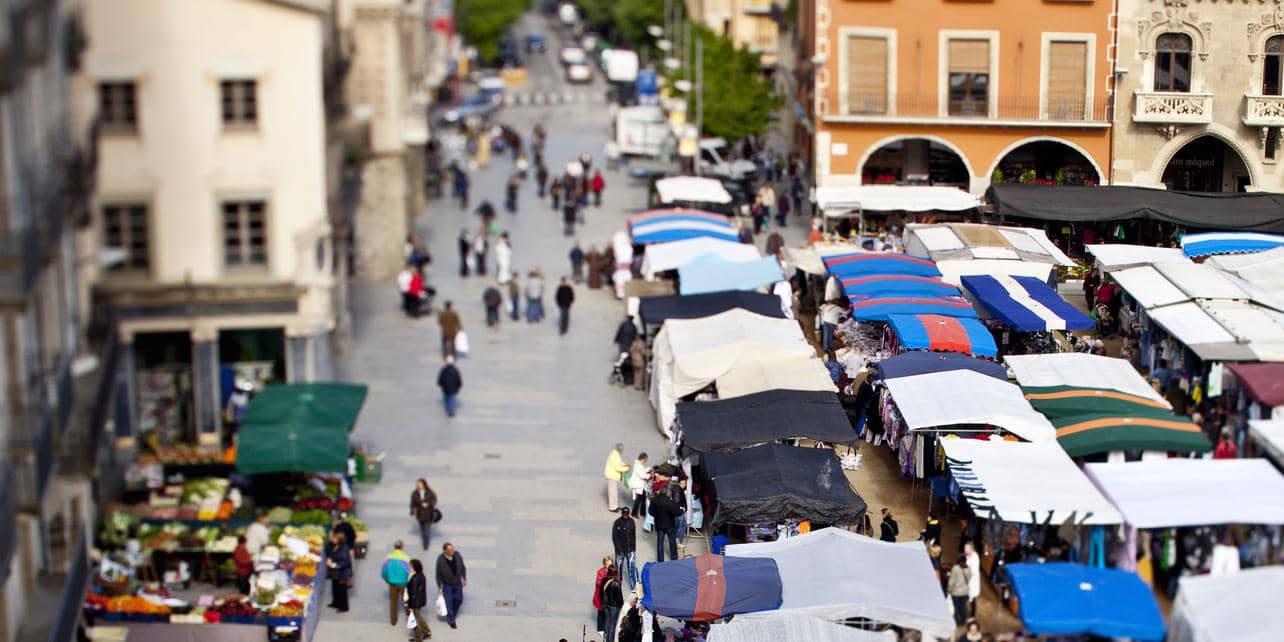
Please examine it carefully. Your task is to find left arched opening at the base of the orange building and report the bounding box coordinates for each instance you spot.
[860,139,971,190]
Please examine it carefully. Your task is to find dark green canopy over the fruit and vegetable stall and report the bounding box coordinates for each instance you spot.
[236,384,366,474]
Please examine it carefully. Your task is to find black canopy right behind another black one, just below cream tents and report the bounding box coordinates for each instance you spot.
[677,390,856,452]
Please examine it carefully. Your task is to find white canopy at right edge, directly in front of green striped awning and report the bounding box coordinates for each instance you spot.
[1084,460,1284,528]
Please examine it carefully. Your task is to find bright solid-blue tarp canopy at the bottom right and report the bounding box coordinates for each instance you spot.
[1007,564,1165,642]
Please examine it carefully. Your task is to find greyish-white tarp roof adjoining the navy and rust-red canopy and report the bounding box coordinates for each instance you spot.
[725,528,954,639]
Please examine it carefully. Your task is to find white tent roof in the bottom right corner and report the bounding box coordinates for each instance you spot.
[1167,566,1284,642]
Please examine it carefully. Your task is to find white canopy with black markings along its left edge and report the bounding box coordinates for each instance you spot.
[939,439,1122,524]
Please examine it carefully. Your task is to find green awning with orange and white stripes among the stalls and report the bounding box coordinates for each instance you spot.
[1022,385,1212,457]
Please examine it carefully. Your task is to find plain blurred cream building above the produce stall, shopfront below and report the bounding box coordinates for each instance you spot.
[73,0,336,440]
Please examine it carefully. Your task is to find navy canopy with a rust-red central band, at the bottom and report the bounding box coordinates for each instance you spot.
[642,553,782,621]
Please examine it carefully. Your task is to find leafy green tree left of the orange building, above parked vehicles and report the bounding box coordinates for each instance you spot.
[674,24,783,141]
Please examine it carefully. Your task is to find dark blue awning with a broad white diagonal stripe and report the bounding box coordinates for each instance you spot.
[962,275,1093,333]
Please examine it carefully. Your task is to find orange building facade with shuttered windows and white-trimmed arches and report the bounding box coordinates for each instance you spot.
[799,0,1113,194]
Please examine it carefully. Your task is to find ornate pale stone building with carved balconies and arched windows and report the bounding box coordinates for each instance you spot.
[1112,0,1284,191]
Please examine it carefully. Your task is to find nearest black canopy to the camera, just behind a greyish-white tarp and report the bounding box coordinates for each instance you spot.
[704,444,865,535]
